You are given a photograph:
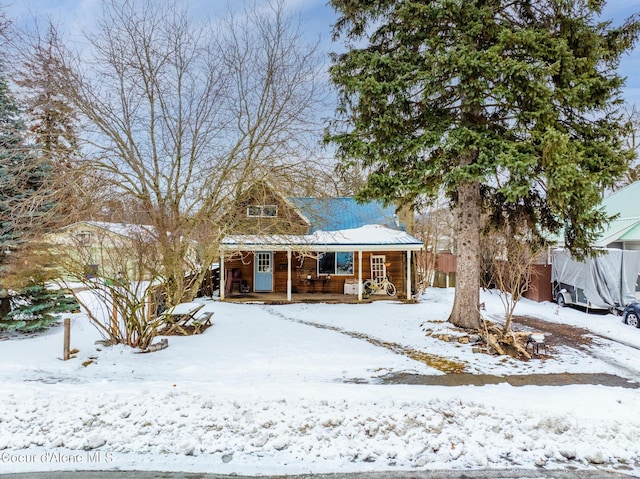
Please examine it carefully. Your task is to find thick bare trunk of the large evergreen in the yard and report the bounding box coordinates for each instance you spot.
[449,181,481,329]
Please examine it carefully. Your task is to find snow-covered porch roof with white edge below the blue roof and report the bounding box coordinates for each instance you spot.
[222,225,423,255]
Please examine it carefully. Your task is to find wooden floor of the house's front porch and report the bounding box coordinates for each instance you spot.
[224,293,406,304]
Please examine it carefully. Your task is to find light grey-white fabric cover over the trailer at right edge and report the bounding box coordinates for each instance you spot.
[551,249,640,308]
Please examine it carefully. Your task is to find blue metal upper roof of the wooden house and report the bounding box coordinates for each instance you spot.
[290,198,404,233]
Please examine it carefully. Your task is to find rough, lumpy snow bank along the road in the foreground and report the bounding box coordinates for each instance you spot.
[0,385,640,474]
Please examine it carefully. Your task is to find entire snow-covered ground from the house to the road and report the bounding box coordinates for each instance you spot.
[0,289,640,475]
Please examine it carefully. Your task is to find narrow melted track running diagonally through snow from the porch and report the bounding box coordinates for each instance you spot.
[263,306,466,374]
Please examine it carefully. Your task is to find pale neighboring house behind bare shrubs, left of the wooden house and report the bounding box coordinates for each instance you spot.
[48,221,155,280]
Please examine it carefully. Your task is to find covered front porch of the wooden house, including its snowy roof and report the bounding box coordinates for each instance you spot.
[220,225,423,303]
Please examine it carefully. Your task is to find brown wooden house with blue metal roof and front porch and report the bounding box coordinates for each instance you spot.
[220,185,423,300]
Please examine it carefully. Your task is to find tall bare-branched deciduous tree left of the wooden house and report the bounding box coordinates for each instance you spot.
[45,0,328,304]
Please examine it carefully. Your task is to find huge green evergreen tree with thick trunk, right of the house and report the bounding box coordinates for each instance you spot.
[327,0,638,328]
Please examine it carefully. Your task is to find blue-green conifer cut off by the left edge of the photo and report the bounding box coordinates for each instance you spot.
[0,64,72,330]
